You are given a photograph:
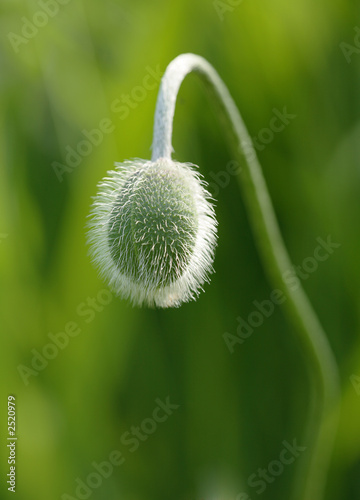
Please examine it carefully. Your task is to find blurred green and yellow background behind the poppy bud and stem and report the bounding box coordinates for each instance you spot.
[0,0,360,500]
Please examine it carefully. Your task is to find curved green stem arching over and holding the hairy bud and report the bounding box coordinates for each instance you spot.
[152,54,340,500]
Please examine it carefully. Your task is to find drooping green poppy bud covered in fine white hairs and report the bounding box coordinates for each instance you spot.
[88,158,217,307]
